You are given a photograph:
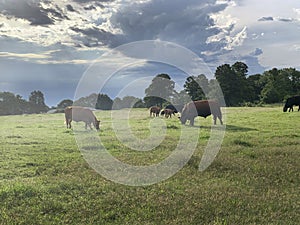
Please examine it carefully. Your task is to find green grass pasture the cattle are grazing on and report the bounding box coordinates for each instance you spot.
[0,107,300,224]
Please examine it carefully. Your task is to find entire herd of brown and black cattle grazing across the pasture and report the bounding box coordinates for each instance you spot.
[65,96,300,130]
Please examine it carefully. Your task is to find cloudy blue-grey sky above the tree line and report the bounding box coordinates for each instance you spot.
[0,0,300,106]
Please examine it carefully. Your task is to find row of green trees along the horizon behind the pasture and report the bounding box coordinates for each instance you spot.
[0,61,300,115]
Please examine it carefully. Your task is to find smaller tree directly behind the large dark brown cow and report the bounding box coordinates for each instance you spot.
[183,74,209,101]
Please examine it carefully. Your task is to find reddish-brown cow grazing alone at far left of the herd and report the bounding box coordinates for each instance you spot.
[65,106,100,131]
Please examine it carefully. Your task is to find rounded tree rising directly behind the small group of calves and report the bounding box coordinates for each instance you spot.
[144,74,175,107]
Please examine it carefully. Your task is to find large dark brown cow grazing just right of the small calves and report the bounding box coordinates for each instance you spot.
[179,100,223,126]
